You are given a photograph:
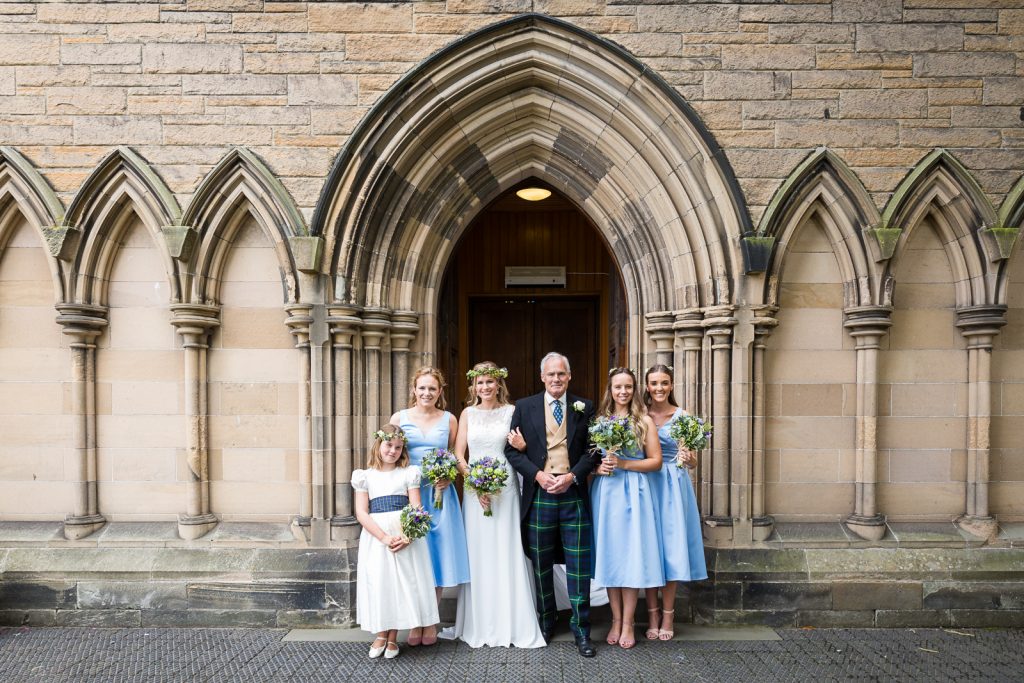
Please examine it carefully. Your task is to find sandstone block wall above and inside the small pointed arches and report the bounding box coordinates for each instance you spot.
[0,0,1024,521]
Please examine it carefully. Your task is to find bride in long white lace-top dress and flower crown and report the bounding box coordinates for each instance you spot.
[453,361,545,647]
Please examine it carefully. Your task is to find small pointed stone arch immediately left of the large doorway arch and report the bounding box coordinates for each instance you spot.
[182,147,308,304]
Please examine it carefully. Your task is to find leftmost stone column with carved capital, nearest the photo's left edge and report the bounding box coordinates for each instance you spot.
[57,304,106,541]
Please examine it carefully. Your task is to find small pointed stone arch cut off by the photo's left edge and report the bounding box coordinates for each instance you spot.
[0,146,65,302]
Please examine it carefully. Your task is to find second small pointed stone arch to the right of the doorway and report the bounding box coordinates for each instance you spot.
[881,148,998,308]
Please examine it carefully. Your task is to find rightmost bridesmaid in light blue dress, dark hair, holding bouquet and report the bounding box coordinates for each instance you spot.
[644,365,708,640]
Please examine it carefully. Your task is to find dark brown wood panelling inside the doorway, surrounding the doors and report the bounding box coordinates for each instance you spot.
[438,194,627,408]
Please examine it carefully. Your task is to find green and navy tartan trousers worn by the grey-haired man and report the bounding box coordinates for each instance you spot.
[526,486,594,637]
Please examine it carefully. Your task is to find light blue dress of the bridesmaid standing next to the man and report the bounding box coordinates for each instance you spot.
[590,440,665,588]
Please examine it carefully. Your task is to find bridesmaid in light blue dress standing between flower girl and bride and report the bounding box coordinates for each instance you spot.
[391,368,469,647]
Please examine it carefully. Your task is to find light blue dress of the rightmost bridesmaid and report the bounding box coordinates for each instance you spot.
[650,408,708,581]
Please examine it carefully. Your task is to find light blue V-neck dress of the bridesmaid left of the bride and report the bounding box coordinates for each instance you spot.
[398,411,469,586]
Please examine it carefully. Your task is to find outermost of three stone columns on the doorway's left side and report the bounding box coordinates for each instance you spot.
[327,306,362,526]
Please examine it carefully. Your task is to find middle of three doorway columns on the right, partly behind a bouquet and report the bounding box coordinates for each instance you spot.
[672,308,711,516]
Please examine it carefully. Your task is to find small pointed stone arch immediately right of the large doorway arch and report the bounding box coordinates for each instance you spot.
[757,147,883,308]
